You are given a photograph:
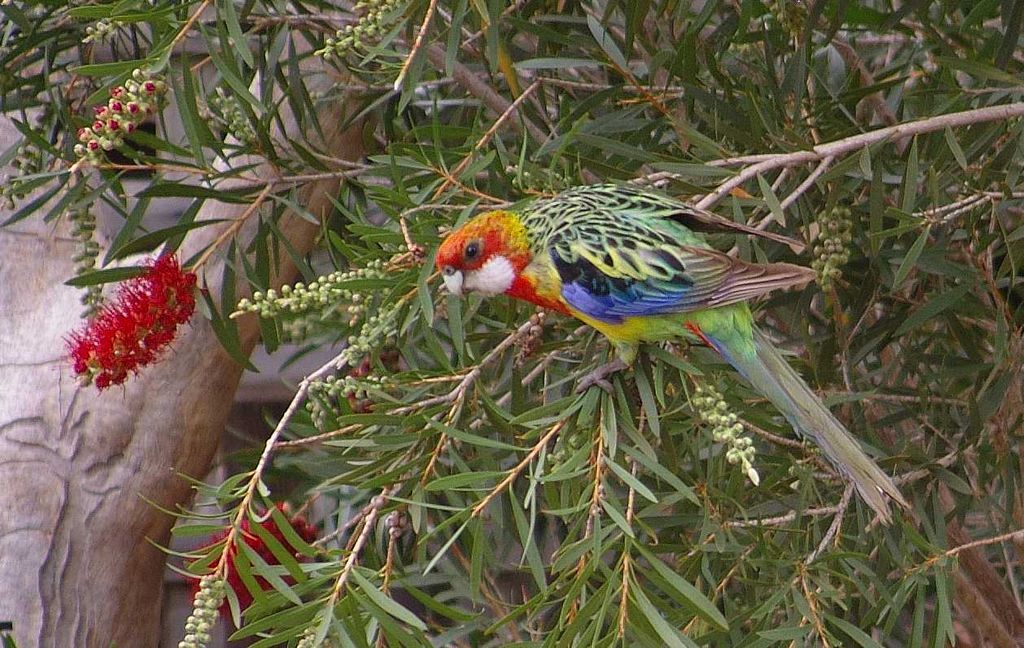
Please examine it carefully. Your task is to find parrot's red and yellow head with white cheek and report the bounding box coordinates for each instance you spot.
[437,211,530,295]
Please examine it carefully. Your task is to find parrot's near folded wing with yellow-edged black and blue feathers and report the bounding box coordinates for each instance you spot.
[549,222,814,322]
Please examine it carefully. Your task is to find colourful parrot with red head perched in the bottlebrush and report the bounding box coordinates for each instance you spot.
[437,184,907,522]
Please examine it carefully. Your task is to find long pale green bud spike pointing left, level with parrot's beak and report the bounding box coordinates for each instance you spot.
[231,259,387,327]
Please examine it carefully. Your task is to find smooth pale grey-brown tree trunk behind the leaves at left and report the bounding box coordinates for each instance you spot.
[0,91,361,647]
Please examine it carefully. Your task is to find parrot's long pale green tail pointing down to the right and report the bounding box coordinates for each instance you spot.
[705,327,908,523]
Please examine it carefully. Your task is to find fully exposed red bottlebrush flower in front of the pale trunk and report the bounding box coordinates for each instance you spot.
[67,252,196,389]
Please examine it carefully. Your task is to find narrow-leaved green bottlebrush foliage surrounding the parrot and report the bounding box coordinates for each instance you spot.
[0,0,1024,648]
